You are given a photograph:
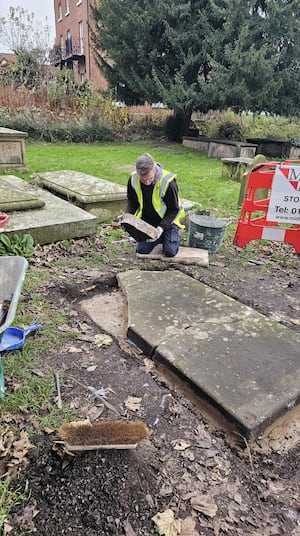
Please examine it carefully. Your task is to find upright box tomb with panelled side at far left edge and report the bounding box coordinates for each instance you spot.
[0,127,28,172]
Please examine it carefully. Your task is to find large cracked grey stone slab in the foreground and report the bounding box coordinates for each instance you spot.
[118,270,300,438]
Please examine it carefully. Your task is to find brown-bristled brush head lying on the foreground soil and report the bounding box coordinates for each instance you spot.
[58,420,149,451]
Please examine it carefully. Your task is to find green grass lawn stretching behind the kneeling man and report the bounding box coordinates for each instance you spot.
[19,142,240,217]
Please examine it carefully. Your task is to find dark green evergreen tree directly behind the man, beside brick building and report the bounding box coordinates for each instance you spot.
[92,0,213,133]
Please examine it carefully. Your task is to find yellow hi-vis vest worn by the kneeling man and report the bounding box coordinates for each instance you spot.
[131,170,185,229]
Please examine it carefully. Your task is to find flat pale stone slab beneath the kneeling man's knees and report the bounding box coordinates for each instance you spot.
[136,244,209,268]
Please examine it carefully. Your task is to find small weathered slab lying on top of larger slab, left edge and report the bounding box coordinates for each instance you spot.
[0,179,45,212]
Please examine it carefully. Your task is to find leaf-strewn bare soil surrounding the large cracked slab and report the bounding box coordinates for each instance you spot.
[7,230,300,536]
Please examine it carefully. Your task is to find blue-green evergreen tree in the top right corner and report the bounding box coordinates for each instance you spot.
[203,0,300,115]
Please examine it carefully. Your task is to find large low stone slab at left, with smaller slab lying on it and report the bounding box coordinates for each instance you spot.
[0,175,99,244]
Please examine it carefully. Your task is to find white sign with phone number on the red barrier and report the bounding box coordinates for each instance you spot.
[266,165,300,224]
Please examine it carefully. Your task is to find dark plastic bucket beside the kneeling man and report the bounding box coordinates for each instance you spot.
[189,214,226,253]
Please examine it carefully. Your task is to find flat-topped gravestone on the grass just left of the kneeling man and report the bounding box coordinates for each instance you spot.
[35,170,127,222]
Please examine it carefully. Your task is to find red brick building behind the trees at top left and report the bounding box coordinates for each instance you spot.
[54,0,107,89]
